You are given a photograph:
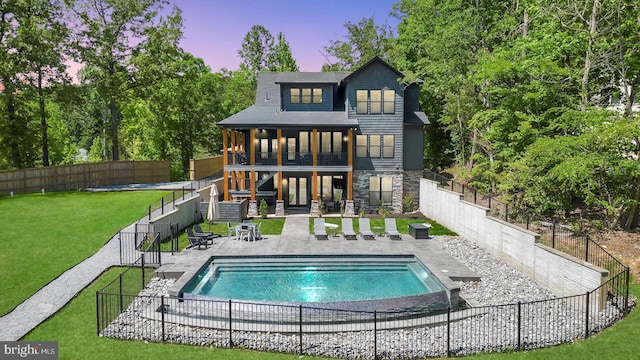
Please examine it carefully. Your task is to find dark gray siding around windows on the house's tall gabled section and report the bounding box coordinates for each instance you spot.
[346,62,404,170]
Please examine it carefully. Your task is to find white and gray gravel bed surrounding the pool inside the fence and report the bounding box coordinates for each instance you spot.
[101,236,623,359]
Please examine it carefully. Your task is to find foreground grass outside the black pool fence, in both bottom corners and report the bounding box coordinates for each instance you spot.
[22,268,640,360]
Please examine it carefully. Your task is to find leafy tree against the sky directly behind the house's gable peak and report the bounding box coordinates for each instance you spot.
[322,18,393,71]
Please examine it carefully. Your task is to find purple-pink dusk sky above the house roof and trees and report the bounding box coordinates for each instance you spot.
[172,0,399,72]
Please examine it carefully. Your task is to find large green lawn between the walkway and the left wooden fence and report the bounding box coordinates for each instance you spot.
[0,191,165,315]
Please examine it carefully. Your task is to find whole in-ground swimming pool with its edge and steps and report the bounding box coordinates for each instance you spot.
[181,256,450,309]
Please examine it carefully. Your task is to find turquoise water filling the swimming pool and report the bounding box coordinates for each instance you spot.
[183,260,445,302]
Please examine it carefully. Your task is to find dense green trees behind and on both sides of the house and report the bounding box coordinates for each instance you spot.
[0,0,640,228]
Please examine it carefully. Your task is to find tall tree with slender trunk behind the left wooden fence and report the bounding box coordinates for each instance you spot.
[71,0,182,161]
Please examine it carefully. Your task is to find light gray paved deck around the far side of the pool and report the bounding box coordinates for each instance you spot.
[156,215,480,295]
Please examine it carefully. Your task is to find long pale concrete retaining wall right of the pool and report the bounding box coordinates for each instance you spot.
[419,179,609,296]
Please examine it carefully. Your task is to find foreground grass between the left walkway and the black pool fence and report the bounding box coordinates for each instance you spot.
[22,268,328,360]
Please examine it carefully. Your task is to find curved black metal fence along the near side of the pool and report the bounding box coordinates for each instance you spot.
[96,262,629,359]
